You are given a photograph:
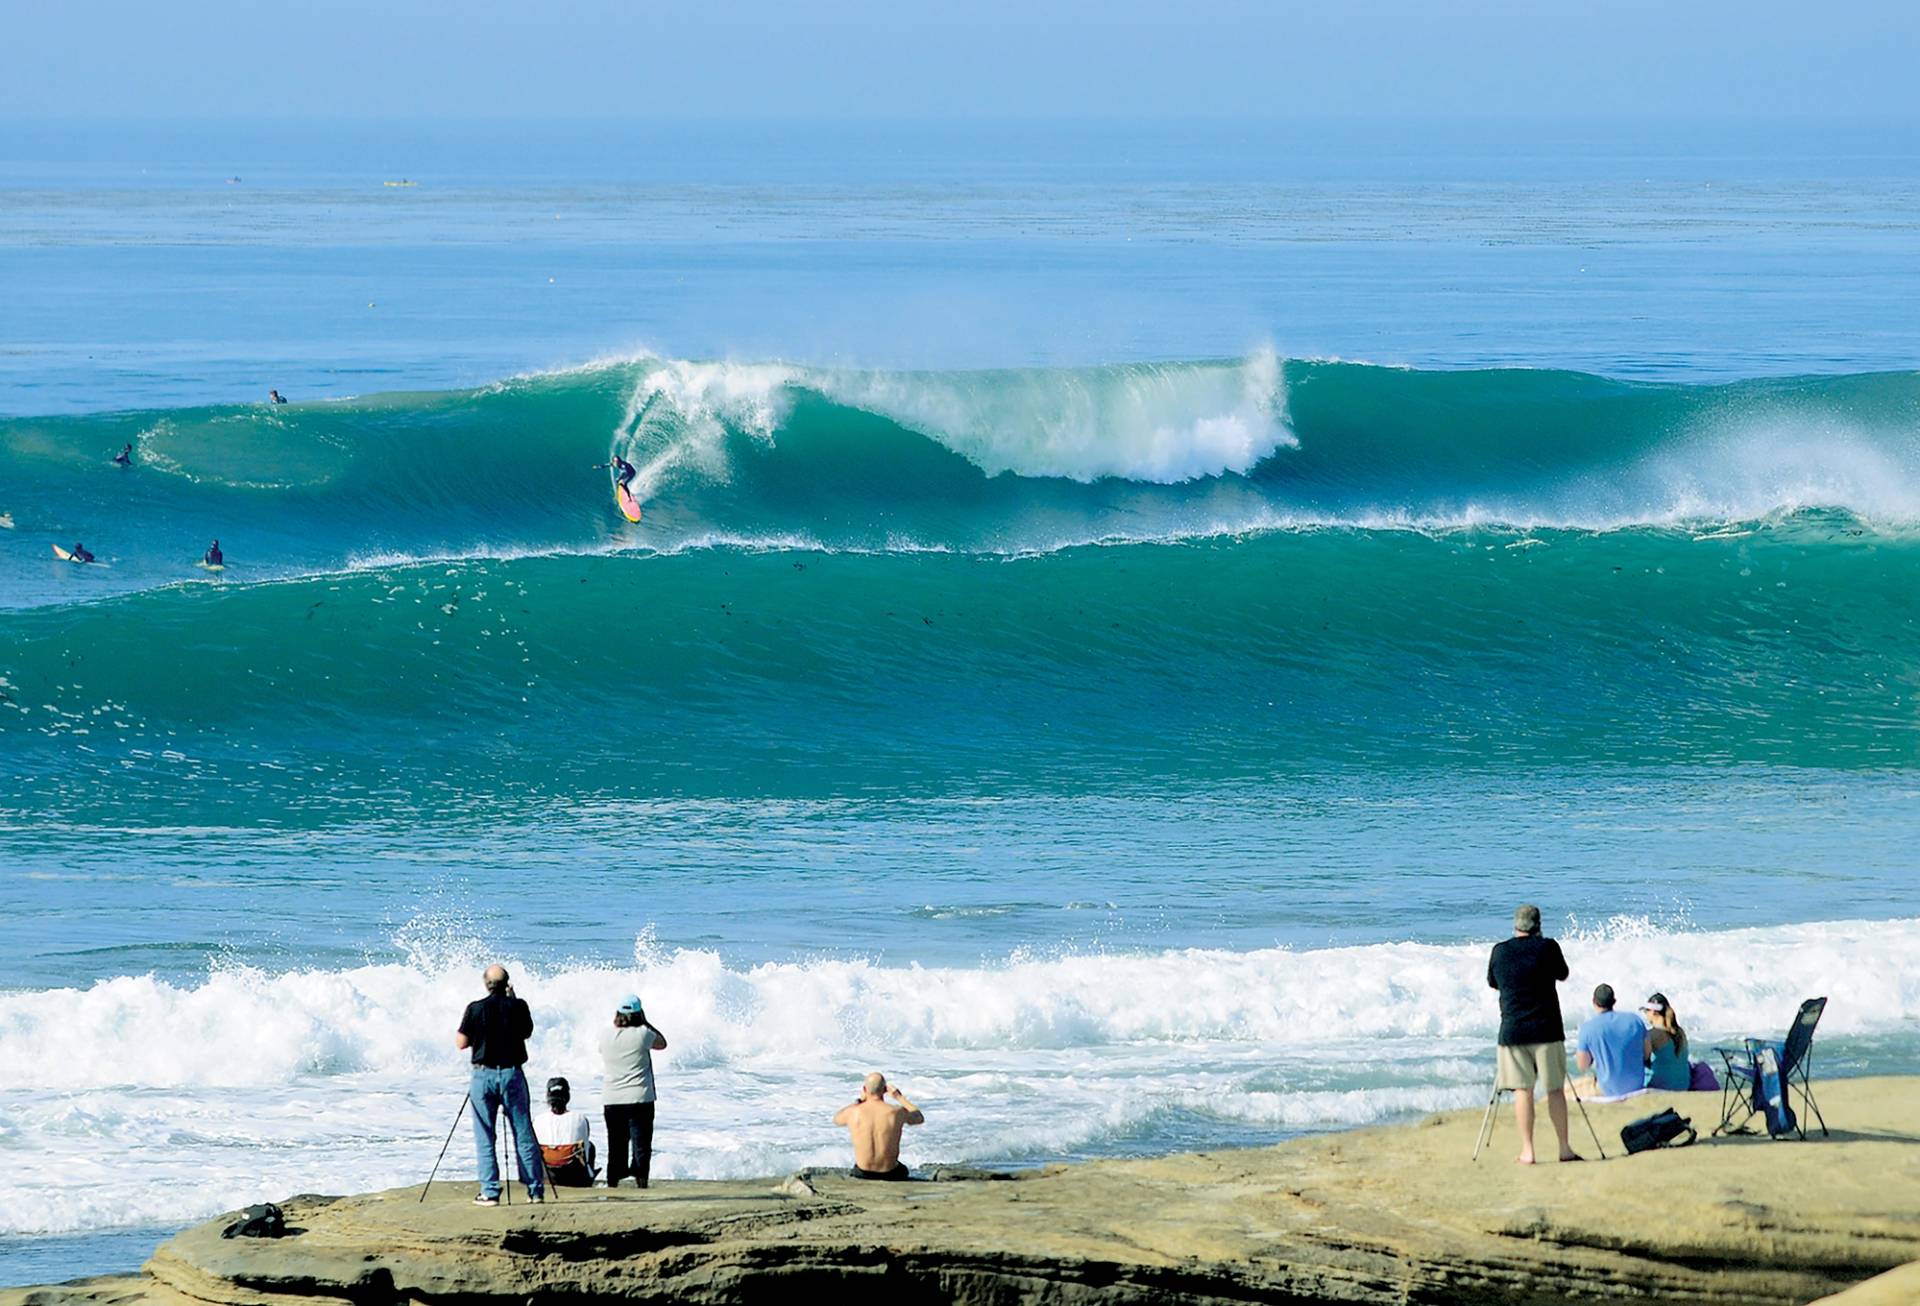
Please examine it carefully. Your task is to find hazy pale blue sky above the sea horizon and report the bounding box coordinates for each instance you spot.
[11,0,1920,129]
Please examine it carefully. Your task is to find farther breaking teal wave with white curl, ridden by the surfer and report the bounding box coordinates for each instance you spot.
[0,355,1920,607]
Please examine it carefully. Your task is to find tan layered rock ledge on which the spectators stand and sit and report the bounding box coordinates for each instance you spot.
[0,1079,1920,1306]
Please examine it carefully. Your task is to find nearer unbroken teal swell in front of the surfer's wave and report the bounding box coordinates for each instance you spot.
[0,517,1920,816]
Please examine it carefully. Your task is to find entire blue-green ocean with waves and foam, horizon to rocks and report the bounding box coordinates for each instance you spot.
[0,121,1920,1283]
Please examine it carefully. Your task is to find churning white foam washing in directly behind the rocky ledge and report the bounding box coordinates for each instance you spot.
[0,920,1920,1233]
